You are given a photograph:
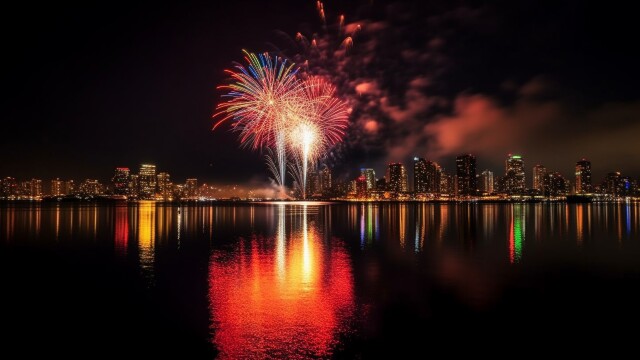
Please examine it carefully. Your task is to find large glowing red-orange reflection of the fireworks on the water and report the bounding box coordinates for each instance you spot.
[209,205,354,359]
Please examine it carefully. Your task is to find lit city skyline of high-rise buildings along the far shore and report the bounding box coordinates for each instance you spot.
[0,154,640,201]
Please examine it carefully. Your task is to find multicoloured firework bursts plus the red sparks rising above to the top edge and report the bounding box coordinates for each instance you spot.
[214,1,360,198]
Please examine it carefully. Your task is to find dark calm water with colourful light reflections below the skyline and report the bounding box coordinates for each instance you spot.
[0,202,640,359]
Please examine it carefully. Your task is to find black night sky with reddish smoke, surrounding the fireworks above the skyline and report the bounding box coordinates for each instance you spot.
[0,0,640,185]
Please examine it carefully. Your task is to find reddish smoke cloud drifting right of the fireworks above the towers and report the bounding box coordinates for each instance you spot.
[268,2,640,178]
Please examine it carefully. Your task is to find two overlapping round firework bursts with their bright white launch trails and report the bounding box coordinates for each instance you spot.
[214,51,348,198]
